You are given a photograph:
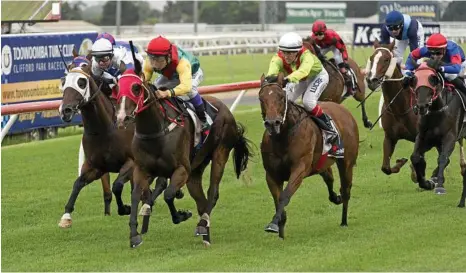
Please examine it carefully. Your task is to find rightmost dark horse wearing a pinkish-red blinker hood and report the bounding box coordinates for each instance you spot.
[410,60,466,207]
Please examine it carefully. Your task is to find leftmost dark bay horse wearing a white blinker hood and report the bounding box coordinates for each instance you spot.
[59,51,189,228]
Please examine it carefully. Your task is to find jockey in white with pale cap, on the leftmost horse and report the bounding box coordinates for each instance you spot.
[91,33,144,92]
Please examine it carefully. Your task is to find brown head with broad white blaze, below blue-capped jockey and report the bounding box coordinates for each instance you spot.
[366,40,396,91]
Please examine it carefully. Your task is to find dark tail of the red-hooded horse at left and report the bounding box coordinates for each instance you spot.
[233,123,253,179]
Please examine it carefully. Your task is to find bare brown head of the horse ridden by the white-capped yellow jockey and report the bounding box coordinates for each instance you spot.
[259,73,288,134]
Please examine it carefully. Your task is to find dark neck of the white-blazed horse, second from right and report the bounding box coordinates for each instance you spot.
[382,67,411,113]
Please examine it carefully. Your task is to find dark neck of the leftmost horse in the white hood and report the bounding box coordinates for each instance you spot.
[81,94,114,134]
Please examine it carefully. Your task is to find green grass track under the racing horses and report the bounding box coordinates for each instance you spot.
[1,94,466,272]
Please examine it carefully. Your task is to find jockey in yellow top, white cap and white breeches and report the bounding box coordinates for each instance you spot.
[267,32,338,148]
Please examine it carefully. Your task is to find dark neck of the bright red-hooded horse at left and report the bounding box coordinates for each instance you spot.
[136,103,165,134]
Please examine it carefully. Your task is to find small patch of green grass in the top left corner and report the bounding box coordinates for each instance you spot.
[2,1,52,21]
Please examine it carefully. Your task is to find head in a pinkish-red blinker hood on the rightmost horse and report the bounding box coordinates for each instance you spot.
[410,60,444,115]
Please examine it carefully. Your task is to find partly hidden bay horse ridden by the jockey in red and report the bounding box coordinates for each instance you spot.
[303,37,372,128]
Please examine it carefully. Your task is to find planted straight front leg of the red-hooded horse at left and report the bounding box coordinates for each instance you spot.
[129,165,152,248]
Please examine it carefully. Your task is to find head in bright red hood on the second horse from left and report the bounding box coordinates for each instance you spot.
[117,69,156,128]
